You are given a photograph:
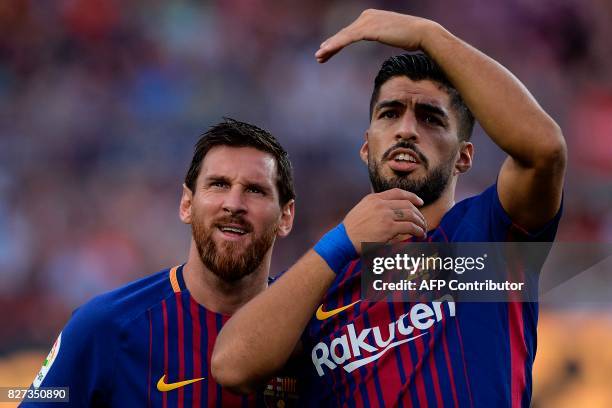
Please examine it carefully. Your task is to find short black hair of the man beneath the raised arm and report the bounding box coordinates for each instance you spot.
[370,52,474,140]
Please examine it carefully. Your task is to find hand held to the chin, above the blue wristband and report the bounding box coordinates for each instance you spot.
[343,188,427,253]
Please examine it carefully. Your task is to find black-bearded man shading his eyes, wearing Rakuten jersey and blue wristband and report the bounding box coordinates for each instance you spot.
[212,10,567,407]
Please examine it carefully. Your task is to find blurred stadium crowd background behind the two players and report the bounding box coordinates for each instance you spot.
[0,0,612,407]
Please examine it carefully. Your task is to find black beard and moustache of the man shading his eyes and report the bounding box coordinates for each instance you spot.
[368,140,454,206]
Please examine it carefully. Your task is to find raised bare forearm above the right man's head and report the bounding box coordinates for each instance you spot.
[421,23,565,167]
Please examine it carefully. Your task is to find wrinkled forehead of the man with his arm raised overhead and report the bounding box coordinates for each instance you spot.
[374,76,451,112]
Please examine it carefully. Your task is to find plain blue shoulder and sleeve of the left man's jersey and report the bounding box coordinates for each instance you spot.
[28,269,177,396]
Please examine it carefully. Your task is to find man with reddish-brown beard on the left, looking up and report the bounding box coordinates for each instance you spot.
[23,119,295,407]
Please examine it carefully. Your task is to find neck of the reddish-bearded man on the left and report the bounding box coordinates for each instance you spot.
[183,239,272,315]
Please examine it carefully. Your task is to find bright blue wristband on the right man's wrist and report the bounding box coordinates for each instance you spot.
[313,223,359,275]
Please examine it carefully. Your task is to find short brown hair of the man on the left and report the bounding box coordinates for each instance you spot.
[185,117,295,206]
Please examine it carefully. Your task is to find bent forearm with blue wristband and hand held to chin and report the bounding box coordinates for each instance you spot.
[211,189,427,393]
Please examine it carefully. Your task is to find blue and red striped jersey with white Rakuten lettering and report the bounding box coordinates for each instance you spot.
[300,185,561,408]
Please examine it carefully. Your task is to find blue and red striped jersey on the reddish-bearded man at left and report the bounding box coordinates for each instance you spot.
[22,266,297,407]
